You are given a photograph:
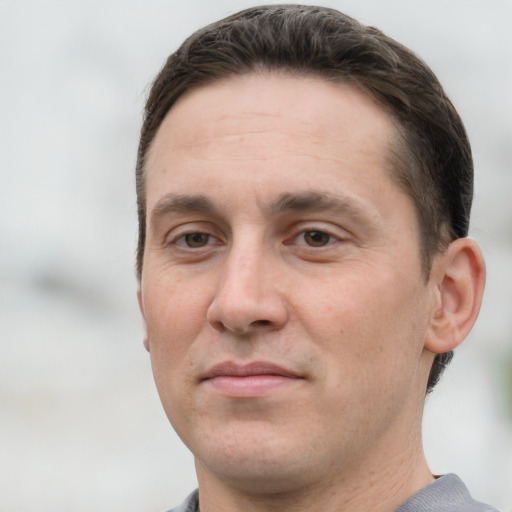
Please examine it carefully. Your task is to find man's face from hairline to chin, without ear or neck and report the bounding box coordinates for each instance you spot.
[139,75,432,490]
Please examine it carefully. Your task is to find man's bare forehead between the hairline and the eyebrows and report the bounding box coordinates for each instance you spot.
[146,73,395,216]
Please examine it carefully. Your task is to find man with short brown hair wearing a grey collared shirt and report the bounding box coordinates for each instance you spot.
[137,5,493,512]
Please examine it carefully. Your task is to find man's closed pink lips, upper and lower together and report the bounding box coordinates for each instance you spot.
[201,361,304,398]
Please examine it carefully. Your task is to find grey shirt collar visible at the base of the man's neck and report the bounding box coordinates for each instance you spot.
[169,474,498,512]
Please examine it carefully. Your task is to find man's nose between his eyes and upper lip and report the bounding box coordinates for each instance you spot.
[207,244,289,335]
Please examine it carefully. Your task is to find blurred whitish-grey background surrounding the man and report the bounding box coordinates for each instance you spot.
[0,0,512,512]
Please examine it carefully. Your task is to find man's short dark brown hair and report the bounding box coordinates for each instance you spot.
[136,5,473,391]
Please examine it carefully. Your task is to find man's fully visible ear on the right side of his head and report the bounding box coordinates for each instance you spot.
[425,238,485,354]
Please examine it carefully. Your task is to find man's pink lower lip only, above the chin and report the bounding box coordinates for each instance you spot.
[205,375,302,398]
